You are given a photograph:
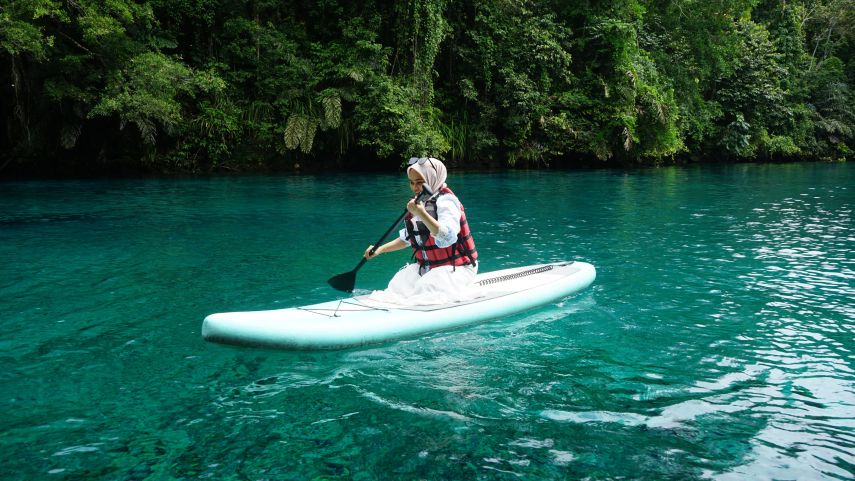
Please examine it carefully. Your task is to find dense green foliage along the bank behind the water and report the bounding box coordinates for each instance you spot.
[0,0,855,171]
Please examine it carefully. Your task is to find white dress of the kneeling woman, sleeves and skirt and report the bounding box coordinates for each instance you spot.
[368,190,479,306]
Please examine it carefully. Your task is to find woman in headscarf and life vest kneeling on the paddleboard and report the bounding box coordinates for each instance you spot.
[365,157,478,305]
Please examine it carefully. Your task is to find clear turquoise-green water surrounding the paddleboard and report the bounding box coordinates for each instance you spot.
[0,164,855,480]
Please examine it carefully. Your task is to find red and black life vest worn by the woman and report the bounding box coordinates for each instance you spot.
[404,187,478,274]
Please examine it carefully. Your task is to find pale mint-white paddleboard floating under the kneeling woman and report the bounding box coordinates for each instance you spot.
[202,261,596,350]
